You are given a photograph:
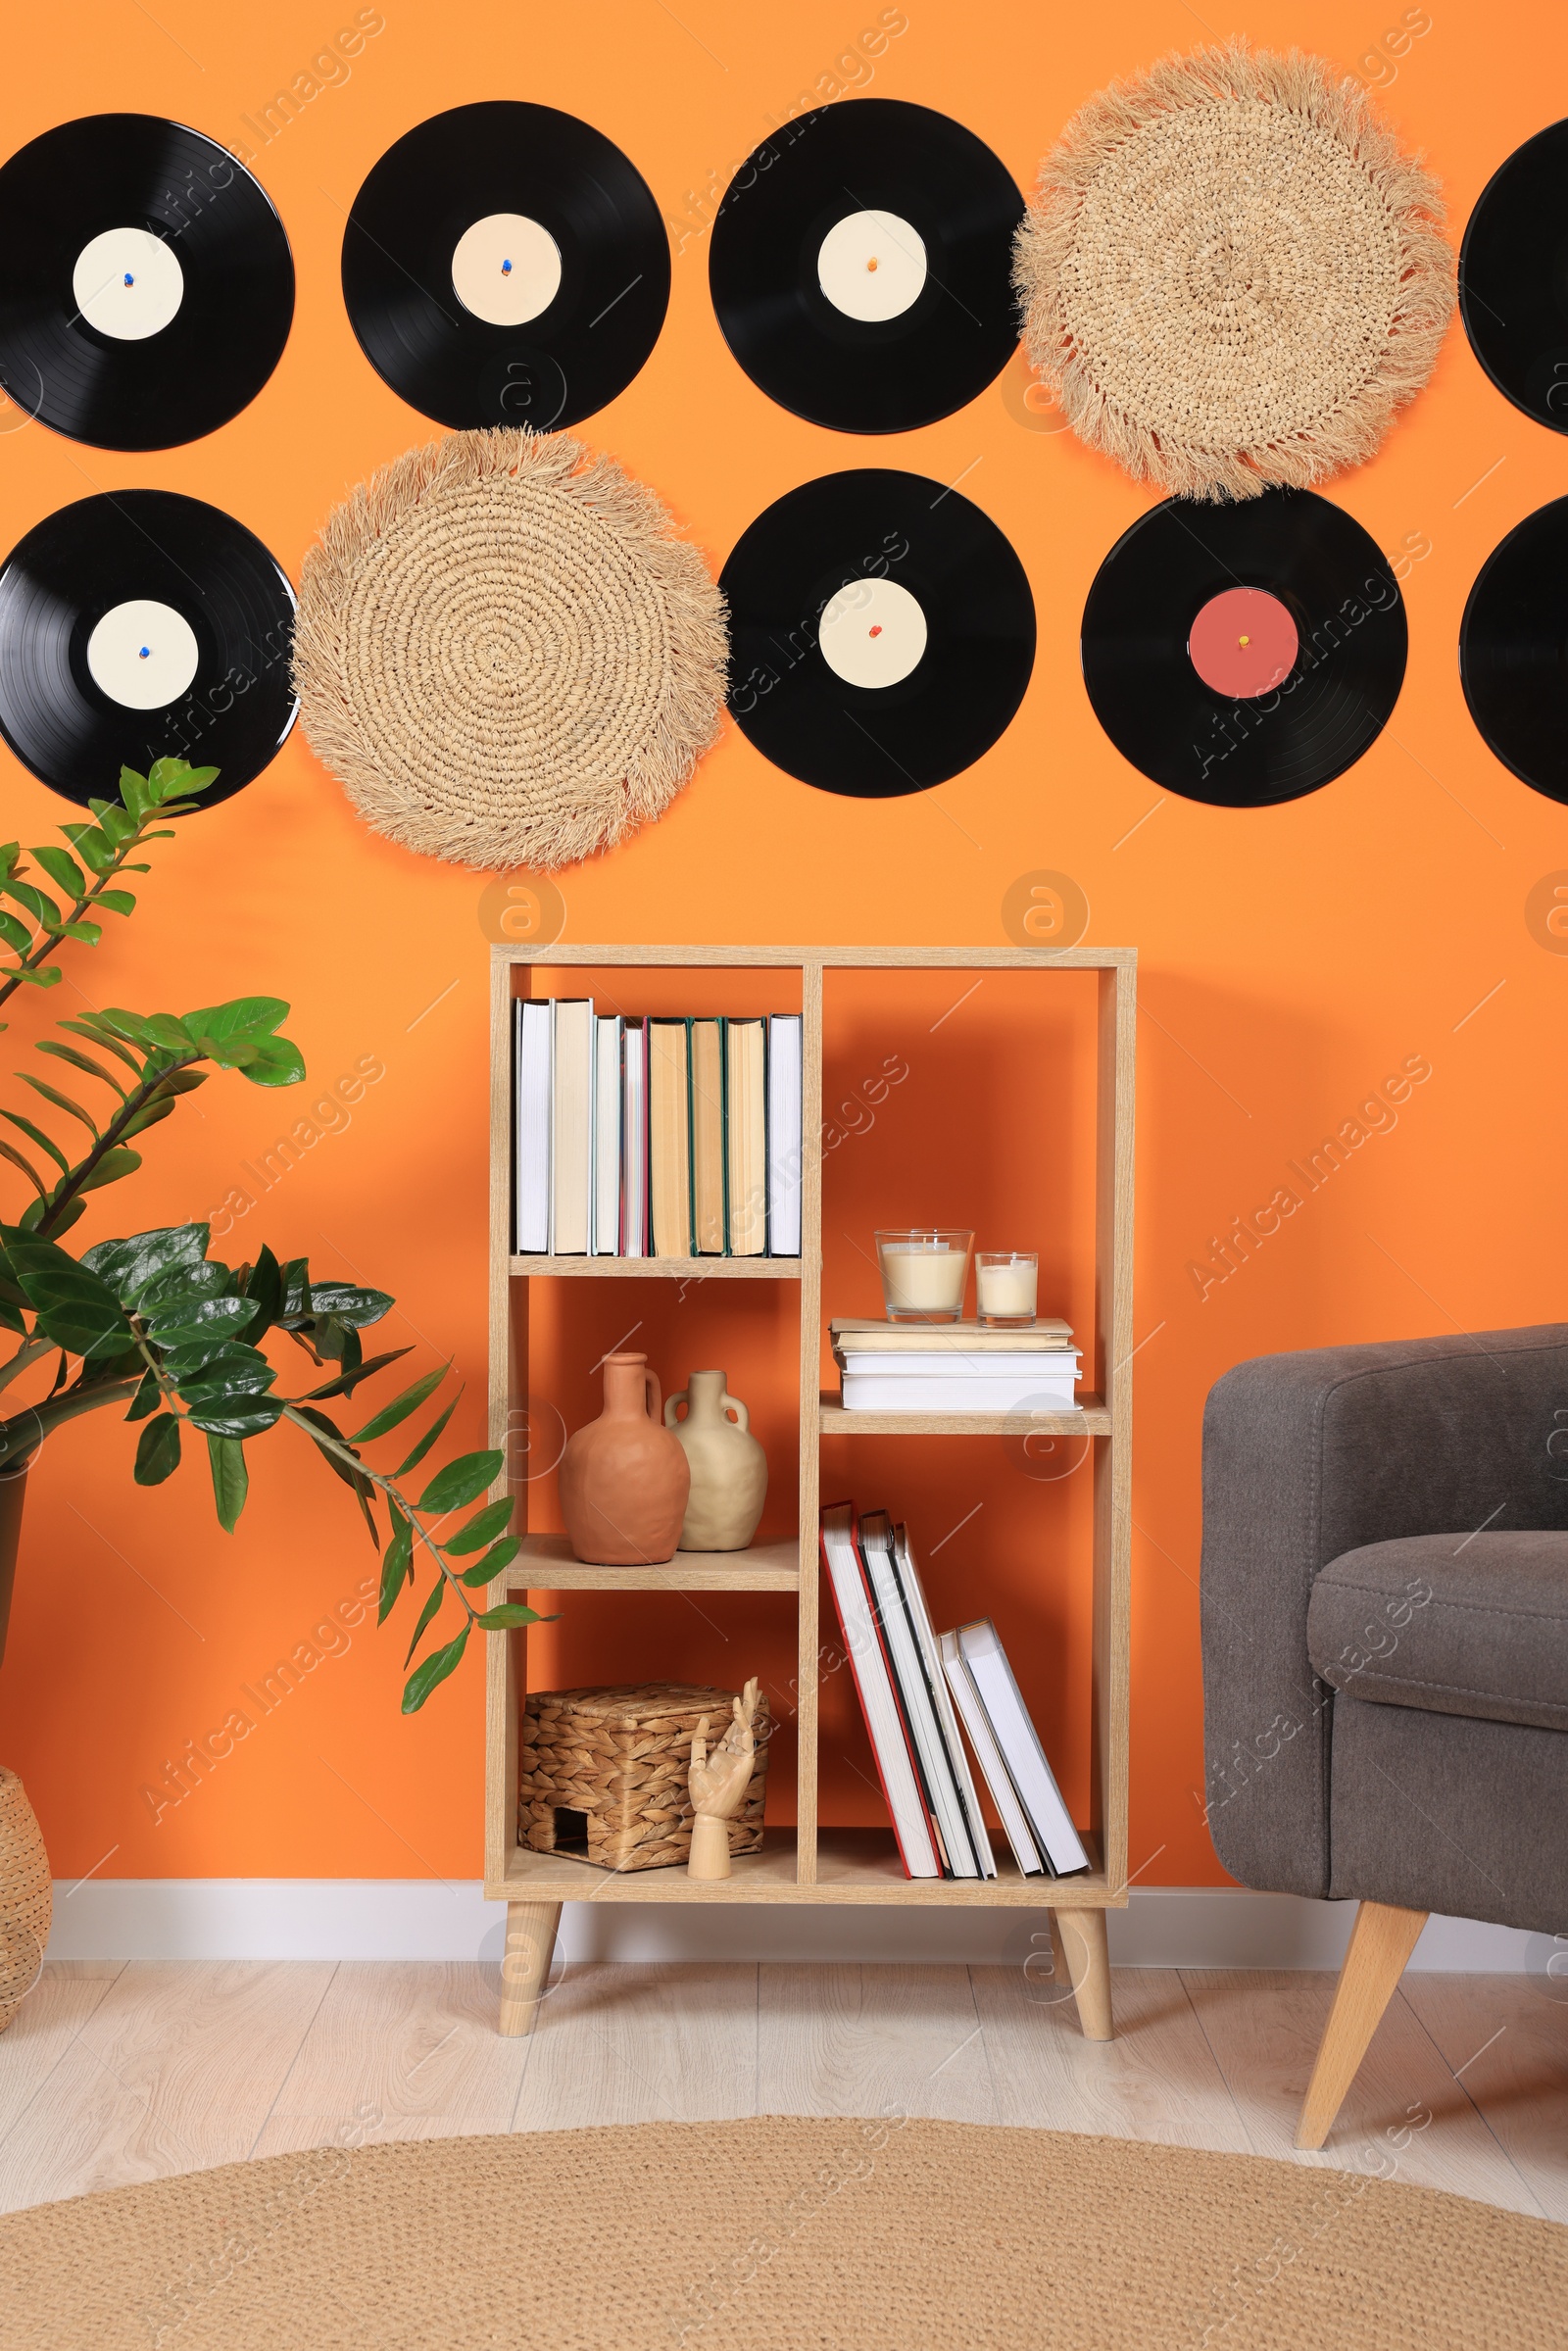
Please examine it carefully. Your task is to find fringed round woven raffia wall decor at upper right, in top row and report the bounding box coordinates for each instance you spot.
[1013,42,1452,499]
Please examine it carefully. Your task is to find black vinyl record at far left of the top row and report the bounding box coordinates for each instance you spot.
[0,116,294,449]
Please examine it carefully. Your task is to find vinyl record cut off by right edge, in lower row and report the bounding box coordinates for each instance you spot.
[1460,499,1568,804]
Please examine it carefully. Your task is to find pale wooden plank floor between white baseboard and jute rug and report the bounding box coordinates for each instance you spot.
[0,1961,1568,2222]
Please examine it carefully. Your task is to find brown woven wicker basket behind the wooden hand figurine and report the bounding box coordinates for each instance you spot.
[517,1681,771,1869]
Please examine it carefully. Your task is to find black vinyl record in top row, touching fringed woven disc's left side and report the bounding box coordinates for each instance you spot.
[708,99,1022,432]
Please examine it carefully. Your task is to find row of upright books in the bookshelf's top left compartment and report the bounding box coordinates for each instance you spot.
[513,997,802,1257]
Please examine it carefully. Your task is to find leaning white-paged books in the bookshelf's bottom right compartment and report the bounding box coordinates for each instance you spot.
[823,1502,1089,1879]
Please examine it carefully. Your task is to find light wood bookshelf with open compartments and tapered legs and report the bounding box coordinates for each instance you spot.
[484,945,1138,2040]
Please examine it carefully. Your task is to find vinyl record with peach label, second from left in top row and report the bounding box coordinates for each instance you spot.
[343,99,670,432]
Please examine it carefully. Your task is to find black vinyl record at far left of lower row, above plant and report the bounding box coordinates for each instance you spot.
[0,489,296,808]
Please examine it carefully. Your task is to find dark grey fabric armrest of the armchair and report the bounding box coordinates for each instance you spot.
[1201,1324,1568,1895]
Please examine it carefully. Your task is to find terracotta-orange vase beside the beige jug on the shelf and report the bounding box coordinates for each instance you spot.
[562,1354,691,1568]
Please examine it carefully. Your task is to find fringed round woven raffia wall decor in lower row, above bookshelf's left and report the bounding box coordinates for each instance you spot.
[294,432,726,870]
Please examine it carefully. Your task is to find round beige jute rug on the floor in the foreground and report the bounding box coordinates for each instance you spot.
[0,2118,1568,2351]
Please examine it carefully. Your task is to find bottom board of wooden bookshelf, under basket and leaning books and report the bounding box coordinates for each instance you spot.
[484,1829,1126,1909]
